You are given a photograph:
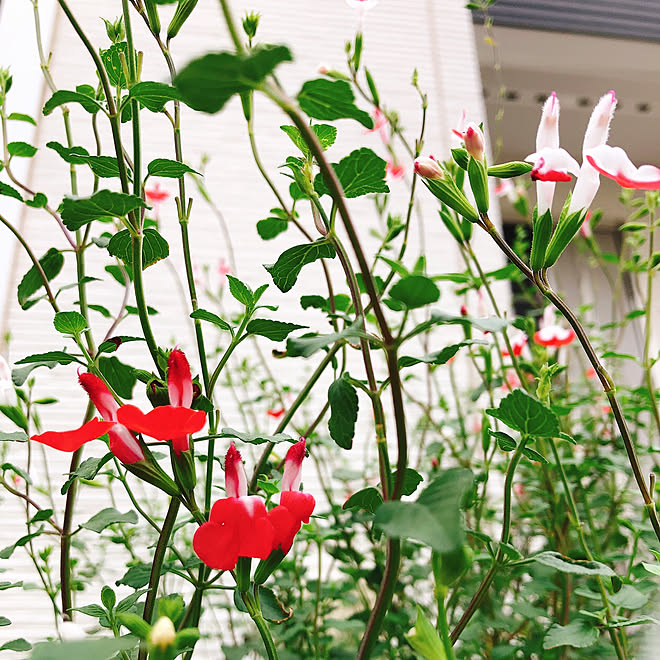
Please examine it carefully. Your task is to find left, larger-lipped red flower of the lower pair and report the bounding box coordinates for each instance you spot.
[193,442,275,571]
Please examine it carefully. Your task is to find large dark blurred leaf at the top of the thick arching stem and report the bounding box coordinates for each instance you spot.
[174,45,292,113]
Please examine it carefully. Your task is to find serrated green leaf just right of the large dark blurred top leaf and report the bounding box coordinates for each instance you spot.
[298,78,374,128]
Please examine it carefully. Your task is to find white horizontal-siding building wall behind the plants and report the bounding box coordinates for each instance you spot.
[0,0,498,658]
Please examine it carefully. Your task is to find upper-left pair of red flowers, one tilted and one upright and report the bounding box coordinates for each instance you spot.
[31,349,206,465]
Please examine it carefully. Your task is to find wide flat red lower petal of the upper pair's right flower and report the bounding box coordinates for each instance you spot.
[117,405,206,440]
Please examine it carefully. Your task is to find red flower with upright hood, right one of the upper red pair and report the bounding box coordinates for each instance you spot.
[117,348,206,456]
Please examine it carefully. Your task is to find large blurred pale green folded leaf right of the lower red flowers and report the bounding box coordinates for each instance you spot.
[375,468,473,552]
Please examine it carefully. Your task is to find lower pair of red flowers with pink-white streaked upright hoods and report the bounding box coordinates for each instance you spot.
[193,439,316,571]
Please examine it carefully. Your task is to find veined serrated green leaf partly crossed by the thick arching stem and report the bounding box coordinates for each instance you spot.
[314,147,390,197]
